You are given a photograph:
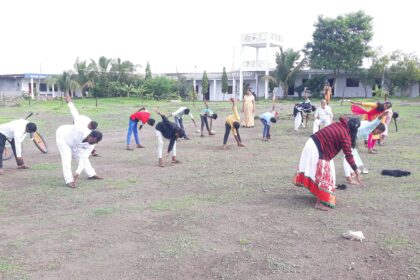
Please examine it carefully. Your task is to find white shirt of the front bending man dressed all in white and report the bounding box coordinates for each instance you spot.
[57,124,95,159]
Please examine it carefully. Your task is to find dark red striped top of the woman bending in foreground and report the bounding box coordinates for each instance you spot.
[311,118,357,171]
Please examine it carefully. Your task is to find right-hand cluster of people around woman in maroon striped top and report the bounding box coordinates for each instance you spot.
[293,100,393,210]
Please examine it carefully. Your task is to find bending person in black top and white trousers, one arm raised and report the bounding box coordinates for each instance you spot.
[155,109,185,167]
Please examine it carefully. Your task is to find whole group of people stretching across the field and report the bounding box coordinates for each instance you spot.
[0,91,392,210]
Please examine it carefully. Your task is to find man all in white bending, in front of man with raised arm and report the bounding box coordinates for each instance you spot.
[56,116,103,188]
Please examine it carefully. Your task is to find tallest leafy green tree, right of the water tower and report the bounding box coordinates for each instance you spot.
[306,11,373,98]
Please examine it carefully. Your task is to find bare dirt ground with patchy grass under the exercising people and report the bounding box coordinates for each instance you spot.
[0,100,420,280]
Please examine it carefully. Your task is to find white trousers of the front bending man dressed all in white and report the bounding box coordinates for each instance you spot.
[56,136,96,184]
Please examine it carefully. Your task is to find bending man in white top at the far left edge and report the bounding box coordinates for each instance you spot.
[0,119,37,175]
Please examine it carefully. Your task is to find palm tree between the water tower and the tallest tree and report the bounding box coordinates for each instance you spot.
[272,47,306,98]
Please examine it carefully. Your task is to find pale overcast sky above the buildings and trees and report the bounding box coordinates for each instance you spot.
[0,0,420,74]
